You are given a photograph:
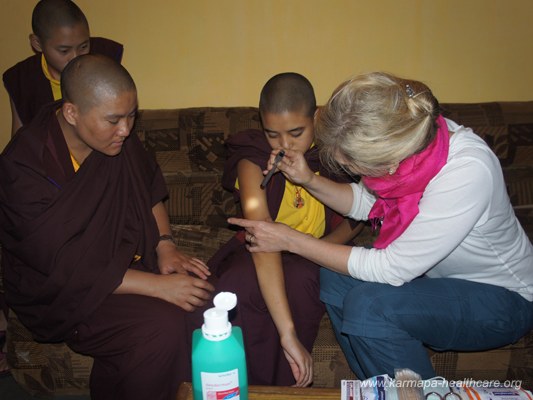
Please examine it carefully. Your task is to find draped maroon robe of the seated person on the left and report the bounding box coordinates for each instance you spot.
[0,103,190,399]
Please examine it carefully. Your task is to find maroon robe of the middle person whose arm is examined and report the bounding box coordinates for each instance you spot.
[208,130,350,386]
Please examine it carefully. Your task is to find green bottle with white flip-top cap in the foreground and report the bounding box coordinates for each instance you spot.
[192,292,248,400]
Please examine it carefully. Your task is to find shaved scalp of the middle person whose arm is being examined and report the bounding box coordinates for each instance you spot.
[259,72,316,117]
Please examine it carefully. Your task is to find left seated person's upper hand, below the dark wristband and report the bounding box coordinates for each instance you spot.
[156,240,211,280]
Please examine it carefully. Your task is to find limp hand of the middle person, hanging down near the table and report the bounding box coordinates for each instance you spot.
[281,334,313,387]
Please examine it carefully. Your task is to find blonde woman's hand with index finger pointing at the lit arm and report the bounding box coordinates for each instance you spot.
[228,218,303,253]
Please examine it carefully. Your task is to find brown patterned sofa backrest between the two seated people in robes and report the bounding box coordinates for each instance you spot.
[135,107,261,228]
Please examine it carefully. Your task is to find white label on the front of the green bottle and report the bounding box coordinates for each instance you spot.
[200,369,241,400]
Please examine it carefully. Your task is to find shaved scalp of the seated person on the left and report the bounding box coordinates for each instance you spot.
[61,54,136,112]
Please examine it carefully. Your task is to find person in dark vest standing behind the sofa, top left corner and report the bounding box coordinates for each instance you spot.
[2,0,124,136]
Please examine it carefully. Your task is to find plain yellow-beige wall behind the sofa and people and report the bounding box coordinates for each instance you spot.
[0,0,533,147]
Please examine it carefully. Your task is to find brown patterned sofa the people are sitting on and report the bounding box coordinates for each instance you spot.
[0,102,533,396]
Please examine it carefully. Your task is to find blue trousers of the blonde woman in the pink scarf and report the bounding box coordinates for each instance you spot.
[320,268,533,379]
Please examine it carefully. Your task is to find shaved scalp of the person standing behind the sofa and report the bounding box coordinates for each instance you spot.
[31,0,89,40]
